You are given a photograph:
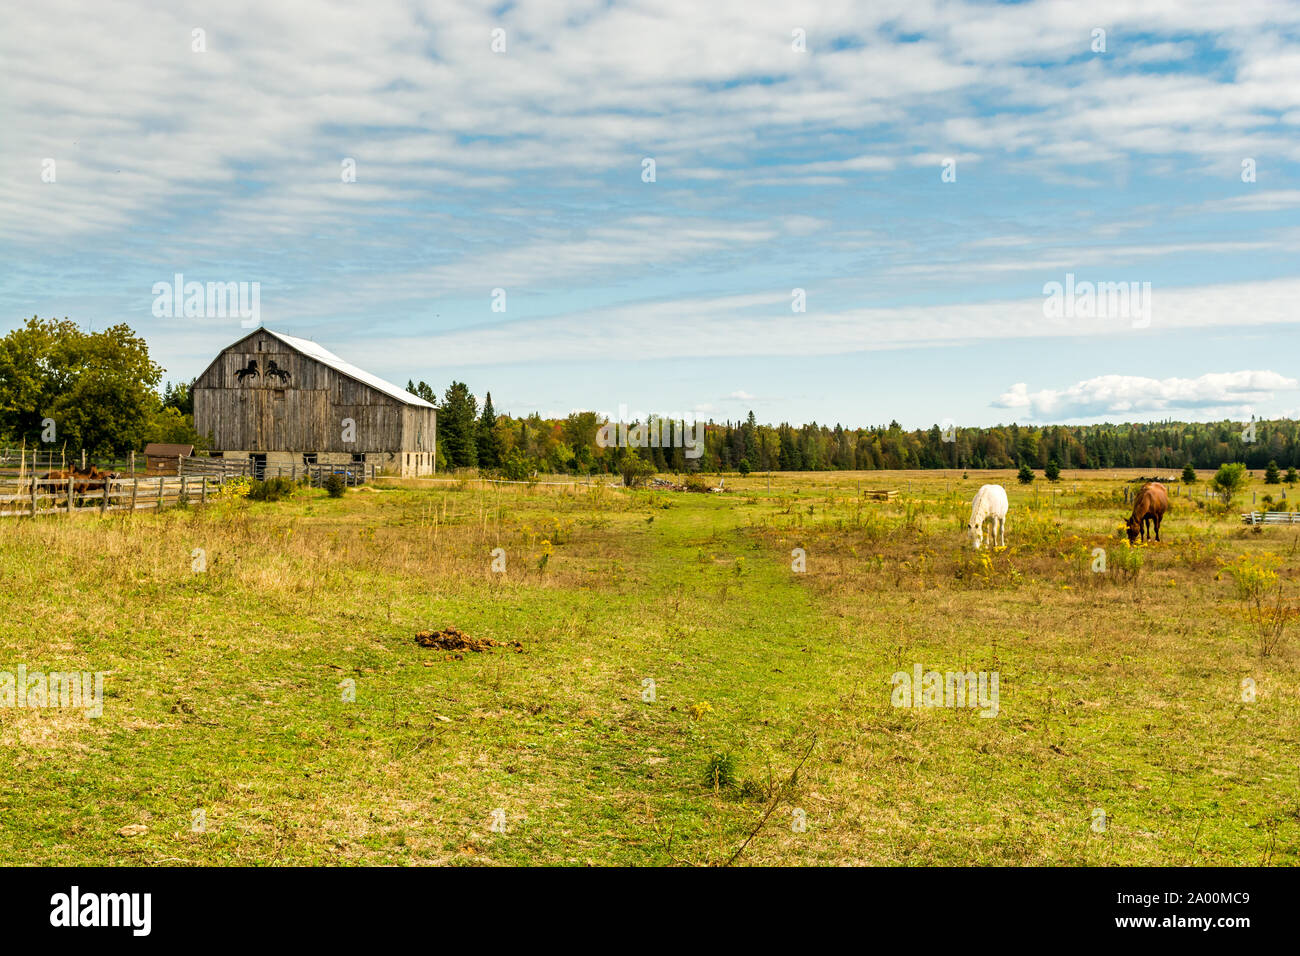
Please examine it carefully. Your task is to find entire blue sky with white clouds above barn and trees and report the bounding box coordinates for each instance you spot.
[0,0,1300,427]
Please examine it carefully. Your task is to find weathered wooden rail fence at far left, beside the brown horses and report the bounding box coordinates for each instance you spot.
[0,476,221,518]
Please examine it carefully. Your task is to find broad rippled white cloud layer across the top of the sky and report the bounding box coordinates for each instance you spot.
[0,0,1300,239]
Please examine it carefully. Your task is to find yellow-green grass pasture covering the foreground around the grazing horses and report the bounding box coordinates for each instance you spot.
[0,472,1300,865]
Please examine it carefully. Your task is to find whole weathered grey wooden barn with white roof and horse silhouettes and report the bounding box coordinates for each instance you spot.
[194,328,438,476]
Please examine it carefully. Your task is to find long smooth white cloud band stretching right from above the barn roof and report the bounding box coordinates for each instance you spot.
[358,280,1300,367]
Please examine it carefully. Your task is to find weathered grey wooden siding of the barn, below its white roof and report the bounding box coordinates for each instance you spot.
[194,330,438,472]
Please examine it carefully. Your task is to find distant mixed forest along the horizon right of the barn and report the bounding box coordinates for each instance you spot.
[407,382,1300,473]
